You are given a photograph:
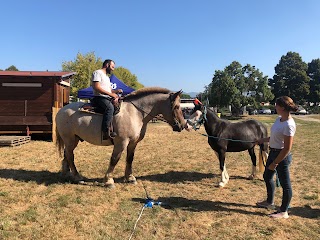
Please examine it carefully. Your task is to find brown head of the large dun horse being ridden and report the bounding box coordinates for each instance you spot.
[166,90,186,132]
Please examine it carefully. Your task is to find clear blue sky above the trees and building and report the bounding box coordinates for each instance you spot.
[0,0,320,92]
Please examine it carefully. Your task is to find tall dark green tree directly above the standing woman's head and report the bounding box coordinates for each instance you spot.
[269,52,310,104]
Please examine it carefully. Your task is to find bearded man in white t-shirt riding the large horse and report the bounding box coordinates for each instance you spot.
[91,59,123,140]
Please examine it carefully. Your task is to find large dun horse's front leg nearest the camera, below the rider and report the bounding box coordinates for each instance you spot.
[104,143,126,188]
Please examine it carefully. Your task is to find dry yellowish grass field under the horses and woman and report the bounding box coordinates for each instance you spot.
[0,116,320,240]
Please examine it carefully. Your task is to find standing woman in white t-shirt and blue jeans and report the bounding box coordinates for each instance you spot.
[256,96,298,218]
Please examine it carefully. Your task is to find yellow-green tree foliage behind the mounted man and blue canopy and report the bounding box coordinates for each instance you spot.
[62,52,143,97]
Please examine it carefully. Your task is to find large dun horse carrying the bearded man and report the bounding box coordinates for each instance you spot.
[56,88,185,187]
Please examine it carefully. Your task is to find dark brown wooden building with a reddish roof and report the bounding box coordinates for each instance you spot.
[0,71,75,136]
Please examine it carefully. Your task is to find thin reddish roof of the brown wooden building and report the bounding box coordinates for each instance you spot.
[0,71,76,78]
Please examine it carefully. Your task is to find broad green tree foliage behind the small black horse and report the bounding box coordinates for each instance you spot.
[207,61,274,115]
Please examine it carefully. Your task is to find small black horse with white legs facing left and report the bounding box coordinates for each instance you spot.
[191,107,268,187]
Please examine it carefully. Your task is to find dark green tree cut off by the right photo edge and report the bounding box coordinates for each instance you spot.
[307,58,320,103]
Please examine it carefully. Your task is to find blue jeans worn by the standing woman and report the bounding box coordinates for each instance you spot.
[263,150,292,212]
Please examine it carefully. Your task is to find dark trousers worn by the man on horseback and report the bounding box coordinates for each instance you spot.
[92,96,114,132]
